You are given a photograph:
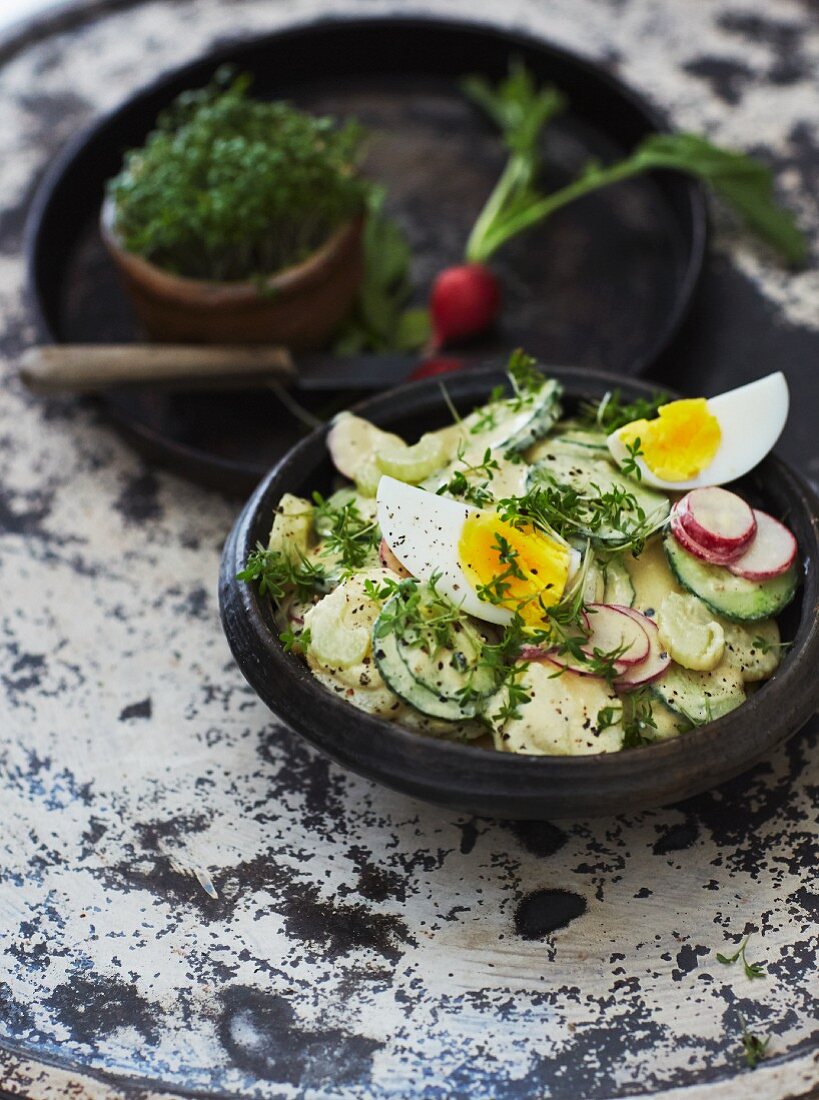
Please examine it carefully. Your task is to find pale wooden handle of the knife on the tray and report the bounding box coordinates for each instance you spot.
[20,344,296,394]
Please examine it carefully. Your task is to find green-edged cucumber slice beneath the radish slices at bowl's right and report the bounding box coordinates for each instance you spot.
[663,535,797,623]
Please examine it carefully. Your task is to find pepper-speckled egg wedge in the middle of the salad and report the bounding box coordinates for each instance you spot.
[377,477,579,625]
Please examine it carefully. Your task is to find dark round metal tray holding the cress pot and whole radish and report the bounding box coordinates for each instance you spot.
[27,17,707,492]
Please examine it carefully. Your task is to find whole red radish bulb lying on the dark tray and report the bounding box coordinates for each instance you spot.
[430,264,500,348]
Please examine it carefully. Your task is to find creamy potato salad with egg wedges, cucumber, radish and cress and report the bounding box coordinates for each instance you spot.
[240,352,798,756]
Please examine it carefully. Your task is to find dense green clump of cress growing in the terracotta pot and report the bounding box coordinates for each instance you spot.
[108,67,372,281]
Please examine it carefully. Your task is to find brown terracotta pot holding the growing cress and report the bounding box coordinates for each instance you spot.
[100,199,364,349]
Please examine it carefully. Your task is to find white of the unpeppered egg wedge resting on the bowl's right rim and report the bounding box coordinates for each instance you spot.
[607,371,789,490]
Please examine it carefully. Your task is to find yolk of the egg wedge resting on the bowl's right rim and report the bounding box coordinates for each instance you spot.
[617,397,722,481]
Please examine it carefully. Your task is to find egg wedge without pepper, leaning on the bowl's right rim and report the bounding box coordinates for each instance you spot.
[608,372,788,490]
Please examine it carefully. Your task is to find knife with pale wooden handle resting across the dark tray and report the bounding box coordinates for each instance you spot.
[19,344,465,394]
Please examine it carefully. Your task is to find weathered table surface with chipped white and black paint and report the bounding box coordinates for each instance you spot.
[0,0,819,1100]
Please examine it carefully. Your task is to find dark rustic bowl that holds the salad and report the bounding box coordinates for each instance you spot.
[220,370,819,818]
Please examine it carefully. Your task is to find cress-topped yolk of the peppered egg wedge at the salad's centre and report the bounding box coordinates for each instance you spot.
[458,515,571,623]
